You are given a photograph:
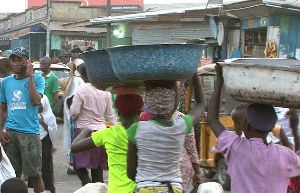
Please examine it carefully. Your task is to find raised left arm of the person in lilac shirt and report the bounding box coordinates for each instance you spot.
[207,64,226,138]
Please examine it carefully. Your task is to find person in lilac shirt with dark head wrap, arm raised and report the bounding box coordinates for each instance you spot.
[207,65,300,193]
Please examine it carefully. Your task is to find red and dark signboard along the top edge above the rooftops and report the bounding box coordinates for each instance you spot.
[27,0,144,12]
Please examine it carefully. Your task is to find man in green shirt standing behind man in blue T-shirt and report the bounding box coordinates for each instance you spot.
[40,56,59,110]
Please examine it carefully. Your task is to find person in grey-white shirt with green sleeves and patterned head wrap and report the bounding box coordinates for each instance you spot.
[127,74,205,193]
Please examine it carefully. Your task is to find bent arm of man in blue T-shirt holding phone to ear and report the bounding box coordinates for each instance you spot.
[26,60,45,106]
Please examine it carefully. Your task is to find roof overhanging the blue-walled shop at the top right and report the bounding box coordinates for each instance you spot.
[223,0,300,20]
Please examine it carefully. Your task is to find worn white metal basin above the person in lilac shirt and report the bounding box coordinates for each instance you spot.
[219,58,300,108]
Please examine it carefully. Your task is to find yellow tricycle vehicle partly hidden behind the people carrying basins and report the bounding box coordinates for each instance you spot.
[198,64,238,190]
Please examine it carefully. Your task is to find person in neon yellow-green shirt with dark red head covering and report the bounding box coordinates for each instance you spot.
[71,94,144,193]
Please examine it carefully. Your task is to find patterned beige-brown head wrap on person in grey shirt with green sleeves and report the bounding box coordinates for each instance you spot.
[146,87,176,115]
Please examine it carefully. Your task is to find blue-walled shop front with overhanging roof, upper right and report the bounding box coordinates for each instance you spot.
[224,0,300,59]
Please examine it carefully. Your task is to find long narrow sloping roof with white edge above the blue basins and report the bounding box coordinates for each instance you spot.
[90,5,221,24]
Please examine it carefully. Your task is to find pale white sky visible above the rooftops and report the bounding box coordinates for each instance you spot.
[0,0,216,13]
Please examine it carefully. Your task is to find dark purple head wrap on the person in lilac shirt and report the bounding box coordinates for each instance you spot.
[246,104,277,132]
